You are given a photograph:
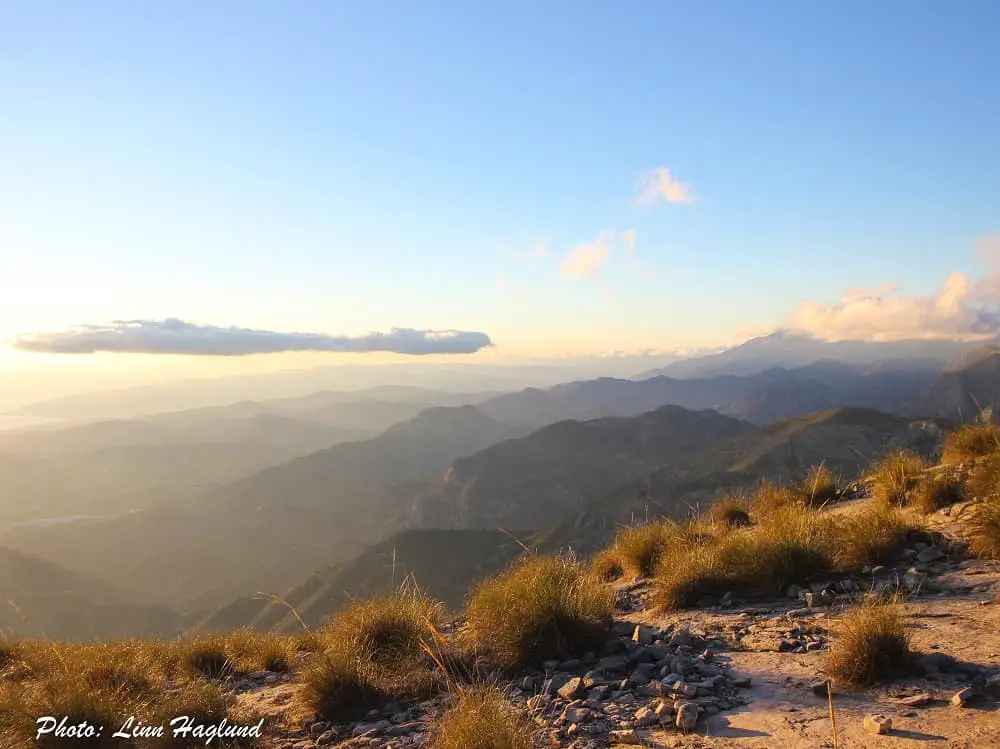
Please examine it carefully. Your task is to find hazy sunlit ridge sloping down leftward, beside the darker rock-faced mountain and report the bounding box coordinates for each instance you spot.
[6,406,516,610]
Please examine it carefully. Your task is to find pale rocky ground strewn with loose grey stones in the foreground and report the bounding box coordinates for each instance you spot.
[227,496,1000,749]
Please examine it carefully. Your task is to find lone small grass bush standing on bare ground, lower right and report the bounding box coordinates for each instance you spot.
[826,600,912,687]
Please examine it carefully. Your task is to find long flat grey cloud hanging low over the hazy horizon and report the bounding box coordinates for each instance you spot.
[12,319,493,356]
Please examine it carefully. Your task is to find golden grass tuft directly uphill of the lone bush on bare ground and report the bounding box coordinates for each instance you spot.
[834,504,921,571]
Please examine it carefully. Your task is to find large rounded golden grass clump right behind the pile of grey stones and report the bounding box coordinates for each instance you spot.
[466,555,613,667]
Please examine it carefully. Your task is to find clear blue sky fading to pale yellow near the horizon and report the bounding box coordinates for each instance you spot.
[0,0,1000,368]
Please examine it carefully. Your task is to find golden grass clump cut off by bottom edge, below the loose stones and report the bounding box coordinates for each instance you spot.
[430,687,534,749]
